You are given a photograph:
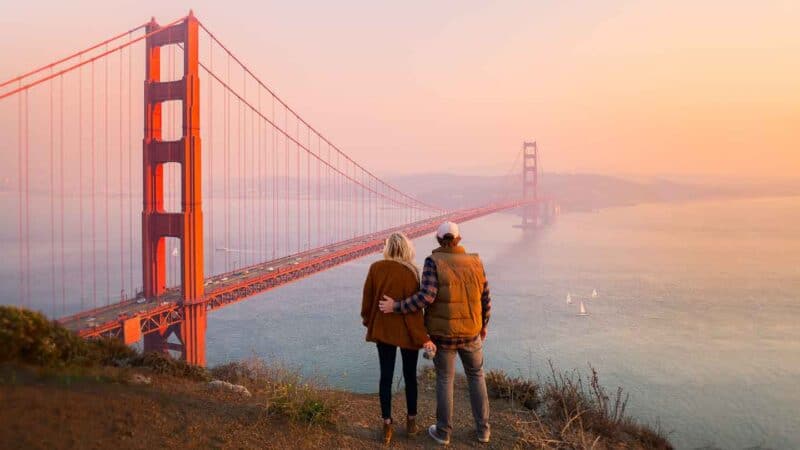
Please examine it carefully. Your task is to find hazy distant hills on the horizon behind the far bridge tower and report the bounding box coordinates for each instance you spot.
[390,173,800,211]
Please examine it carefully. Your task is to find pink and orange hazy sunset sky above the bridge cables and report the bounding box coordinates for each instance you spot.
[0,0,800,178]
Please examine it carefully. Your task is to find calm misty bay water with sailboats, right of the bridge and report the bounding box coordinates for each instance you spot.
[207,197,800,448]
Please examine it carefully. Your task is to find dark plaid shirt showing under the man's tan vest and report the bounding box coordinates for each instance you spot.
[394,257,492,350]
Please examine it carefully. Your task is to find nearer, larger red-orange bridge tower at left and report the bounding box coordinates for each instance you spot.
[142,12,206,365]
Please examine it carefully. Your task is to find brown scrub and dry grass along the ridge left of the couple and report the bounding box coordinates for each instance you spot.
[0,306,341,424]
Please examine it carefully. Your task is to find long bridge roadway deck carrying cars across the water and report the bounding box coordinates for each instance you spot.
[60,199,541,338]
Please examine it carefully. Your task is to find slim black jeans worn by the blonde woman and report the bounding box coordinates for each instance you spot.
[378,342,419,419]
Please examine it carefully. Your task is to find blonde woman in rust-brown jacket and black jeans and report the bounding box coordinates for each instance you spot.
[361,233,433,444]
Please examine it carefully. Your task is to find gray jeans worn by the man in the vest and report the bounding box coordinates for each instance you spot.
[433,339,489,438]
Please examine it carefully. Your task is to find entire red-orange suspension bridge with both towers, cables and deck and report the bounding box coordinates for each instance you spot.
[0,12,549,365]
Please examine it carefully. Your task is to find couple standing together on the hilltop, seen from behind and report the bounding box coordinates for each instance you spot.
[361,222,491,445]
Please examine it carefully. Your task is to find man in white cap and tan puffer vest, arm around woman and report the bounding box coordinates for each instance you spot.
[379,222,491,445]
